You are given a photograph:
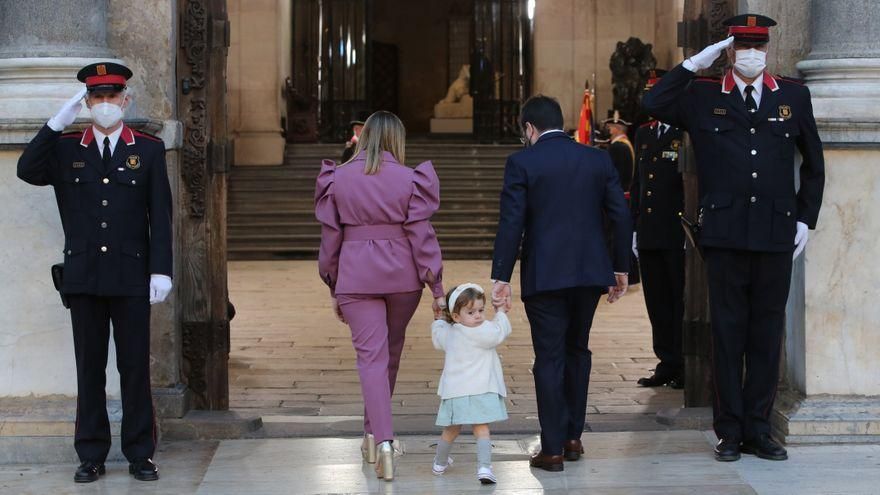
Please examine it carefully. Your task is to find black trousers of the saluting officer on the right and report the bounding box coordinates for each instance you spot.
[705,247,792,442]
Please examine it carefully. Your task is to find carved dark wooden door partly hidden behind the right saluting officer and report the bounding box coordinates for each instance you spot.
[678,0,736,407]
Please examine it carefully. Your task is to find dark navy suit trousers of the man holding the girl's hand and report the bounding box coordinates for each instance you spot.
[523,287,602,455]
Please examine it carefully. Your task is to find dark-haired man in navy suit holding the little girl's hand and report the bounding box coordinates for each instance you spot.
[492,95,632,471]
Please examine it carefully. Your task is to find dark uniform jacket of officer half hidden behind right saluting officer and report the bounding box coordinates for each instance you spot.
[630,120,684,250]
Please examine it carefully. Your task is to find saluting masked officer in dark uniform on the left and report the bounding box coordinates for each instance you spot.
[18,62,172,482]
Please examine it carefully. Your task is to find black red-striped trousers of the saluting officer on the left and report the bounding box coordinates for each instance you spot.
[68,294,156,462]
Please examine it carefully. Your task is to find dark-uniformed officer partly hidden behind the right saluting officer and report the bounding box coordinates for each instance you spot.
[630,69,684,388]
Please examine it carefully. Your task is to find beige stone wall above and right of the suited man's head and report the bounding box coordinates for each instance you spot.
[534,0,684,127]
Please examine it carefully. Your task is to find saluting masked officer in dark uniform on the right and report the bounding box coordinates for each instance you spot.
[642,14,825,461]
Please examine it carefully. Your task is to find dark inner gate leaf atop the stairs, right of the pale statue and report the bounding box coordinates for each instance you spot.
[471,0,532,142]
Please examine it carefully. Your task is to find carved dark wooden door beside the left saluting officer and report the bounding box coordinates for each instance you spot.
[175,0,231,410]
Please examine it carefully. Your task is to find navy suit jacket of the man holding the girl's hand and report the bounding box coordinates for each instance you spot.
[492,132,632,298]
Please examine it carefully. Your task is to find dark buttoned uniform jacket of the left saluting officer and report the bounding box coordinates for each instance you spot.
[18,126,172,296]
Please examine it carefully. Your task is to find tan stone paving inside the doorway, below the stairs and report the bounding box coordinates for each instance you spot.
[223,260,682,435]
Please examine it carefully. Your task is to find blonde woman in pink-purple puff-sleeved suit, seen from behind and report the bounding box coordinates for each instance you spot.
[315,112,445,481]
